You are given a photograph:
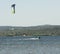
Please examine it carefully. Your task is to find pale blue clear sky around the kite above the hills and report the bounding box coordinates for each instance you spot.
[0,0,60,26]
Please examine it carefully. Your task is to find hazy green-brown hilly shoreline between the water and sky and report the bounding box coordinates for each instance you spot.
[0,25,60,36]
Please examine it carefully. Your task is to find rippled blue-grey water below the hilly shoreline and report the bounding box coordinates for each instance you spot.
[0,36,60,54]
